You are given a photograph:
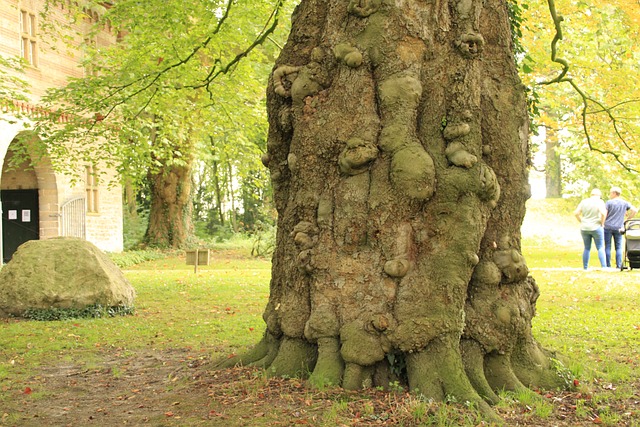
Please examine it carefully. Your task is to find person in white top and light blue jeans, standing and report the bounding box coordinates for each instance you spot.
[573,188,607,270]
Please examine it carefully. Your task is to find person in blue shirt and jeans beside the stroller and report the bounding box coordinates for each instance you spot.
[604,187,638,268]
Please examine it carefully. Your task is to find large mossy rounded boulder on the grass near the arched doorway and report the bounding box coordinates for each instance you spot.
[0,237,135,317]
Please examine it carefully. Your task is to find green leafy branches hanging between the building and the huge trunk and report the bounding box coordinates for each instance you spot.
[32,0,283,187]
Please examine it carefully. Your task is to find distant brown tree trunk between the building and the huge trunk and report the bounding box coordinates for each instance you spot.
[143,158,193,248]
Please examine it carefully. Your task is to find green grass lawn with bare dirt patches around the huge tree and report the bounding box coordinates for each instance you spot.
[0,201,640,427]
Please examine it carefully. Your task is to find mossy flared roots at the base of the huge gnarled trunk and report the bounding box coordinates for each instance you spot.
[215,332,568,424]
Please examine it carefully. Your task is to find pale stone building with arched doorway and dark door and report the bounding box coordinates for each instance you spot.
[0,0,123,262]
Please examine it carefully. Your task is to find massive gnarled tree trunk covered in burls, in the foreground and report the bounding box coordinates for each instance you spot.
[219,0,559,418]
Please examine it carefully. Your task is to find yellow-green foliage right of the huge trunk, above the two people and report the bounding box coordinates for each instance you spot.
[518,0,640,196]
